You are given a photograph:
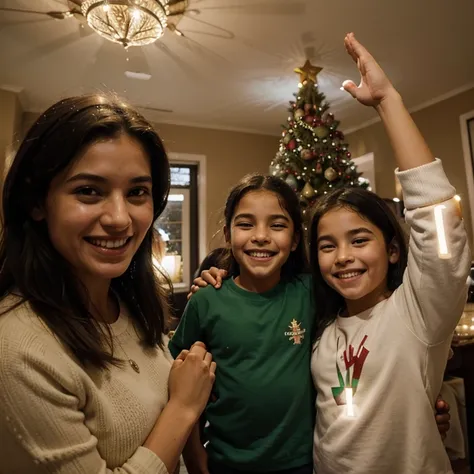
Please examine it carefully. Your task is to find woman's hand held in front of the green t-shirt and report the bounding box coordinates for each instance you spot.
[168,342,216,420]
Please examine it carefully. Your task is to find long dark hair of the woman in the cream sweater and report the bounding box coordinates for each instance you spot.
[0,94,170,368]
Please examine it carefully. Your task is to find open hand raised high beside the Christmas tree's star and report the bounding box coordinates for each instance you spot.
[342,33,397,107]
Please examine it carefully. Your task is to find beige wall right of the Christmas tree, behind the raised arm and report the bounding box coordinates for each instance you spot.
[346,89,474,251]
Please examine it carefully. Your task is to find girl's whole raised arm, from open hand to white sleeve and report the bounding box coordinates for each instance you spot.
[343,34,471,345]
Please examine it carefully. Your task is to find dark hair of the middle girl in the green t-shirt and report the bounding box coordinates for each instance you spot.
[220,174,309,279]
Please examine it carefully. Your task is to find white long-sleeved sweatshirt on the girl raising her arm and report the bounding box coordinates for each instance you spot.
[311,160,471,474]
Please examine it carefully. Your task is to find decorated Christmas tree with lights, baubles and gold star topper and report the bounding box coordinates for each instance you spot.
[270,61,369,220]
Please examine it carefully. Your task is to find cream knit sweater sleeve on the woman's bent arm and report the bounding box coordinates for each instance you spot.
[0,315,168,474]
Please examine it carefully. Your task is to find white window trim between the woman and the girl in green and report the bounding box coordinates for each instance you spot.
[168,152,207,262]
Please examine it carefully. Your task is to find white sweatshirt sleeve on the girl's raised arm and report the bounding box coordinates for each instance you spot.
[393,160,471,344]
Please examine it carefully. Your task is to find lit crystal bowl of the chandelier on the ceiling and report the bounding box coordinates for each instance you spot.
[81,0,170,48]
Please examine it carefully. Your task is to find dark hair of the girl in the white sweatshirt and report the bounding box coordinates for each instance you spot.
[309,188,408,339]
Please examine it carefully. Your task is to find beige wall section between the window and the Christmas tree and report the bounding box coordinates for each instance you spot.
[22,113,279,247]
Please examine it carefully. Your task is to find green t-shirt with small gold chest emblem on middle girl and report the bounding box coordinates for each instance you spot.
[169,275,314,472]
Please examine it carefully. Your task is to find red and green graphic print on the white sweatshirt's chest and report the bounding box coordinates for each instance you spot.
[331,335,369,405]
